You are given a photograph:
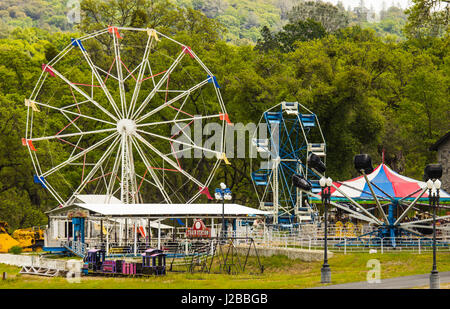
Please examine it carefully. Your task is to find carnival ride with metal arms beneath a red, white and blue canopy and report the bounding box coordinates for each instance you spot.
[300,154,450,247]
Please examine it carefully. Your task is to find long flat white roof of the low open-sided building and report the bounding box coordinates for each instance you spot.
[49,203,270,218]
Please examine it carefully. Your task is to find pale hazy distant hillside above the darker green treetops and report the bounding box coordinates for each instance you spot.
[0,0,414,45]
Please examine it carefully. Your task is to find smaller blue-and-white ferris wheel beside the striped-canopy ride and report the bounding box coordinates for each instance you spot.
[251,102,326,224]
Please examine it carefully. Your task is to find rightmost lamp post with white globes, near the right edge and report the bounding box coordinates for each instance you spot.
[425,164,442,289]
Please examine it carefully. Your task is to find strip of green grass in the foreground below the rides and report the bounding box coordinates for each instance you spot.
[0,252,450,289]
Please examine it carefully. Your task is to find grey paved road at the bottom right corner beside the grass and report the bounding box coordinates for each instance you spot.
[315,271,450,289]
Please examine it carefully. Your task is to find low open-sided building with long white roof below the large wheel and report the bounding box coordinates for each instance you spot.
[44,195,269,255]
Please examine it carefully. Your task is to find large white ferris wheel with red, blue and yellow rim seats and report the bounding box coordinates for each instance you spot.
[22,27,229,206]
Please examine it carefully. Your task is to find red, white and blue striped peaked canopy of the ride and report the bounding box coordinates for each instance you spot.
[331,164,450,202]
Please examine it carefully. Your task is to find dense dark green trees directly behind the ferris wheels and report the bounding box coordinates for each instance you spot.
[0,0,450,229]
